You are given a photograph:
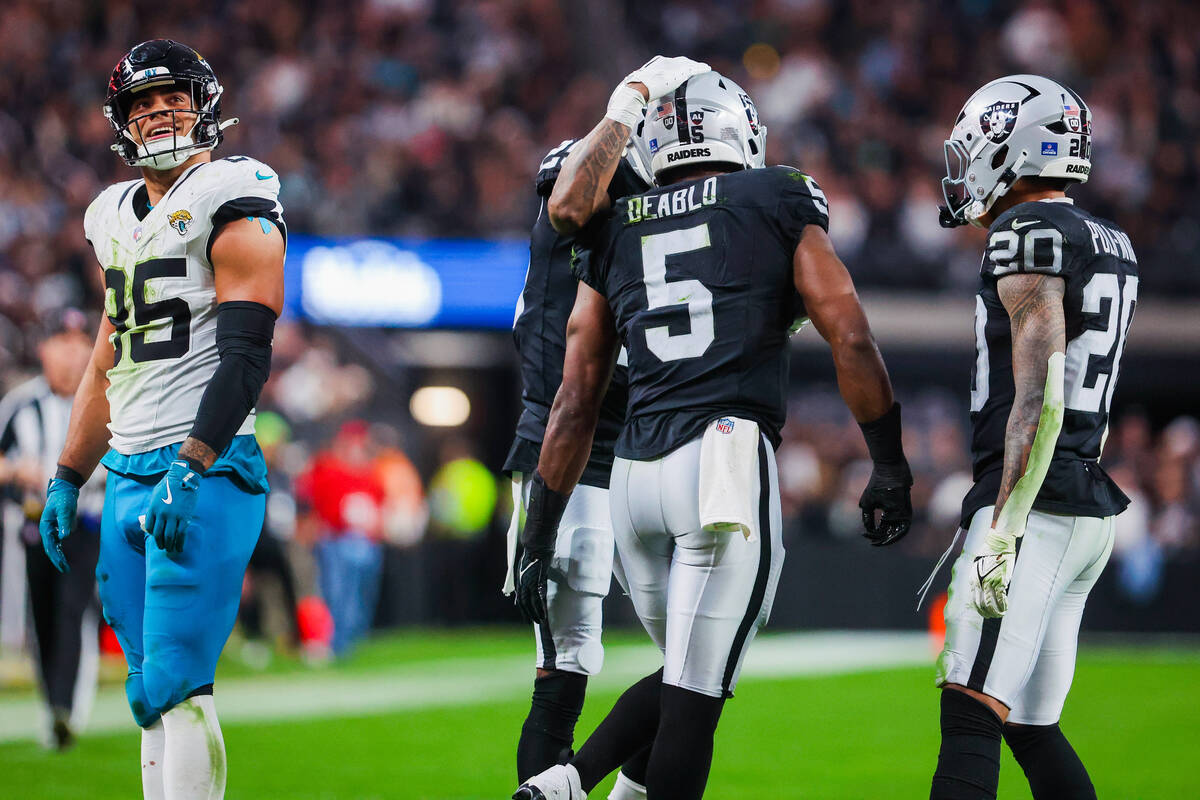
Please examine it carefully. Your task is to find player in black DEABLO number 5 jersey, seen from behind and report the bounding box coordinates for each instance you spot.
[514,72,912,800]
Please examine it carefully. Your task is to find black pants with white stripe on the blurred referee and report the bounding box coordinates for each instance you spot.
[25,527,100,712]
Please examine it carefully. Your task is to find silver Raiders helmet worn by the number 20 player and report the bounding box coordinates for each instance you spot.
[941,76,1092,228]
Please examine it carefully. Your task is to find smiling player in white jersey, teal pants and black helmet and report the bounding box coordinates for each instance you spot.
[41,40,286,800]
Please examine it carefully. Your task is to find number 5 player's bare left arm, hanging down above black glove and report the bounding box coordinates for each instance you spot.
[538,283,617,494]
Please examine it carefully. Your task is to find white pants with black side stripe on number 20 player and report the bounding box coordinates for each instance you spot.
[937,506,1116,726]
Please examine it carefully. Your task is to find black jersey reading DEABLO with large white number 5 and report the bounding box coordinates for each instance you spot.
[572,167,829,459]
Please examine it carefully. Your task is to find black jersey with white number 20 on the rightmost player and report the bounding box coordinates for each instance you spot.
[962,200,1138,527]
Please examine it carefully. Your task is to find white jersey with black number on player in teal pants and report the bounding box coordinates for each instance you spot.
[84,156,286,455]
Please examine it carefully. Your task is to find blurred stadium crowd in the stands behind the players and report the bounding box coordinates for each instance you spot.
[0,0,1200,638]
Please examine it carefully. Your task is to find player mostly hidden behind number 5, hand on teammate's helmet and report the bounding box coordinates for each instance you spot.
[504,56,708,800]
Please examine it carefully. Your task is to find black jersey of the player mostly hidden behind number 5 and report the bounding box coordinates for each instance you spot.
[504,139,647,488]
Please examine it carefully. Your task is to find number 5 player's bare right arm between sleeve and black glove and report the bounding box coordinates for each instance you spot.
[793,225,894,422]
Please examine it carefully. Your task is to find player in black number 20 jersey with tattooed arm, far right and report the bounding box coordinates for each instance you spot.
[930,76,1138,800]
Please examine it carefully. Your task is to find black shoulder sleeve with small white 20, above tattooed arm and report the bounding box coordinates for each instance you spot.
[979,201,1092,278]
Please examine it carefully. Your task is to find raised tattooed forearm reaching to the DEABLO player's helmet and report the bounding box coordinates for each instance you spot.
[546,118,630,235]
